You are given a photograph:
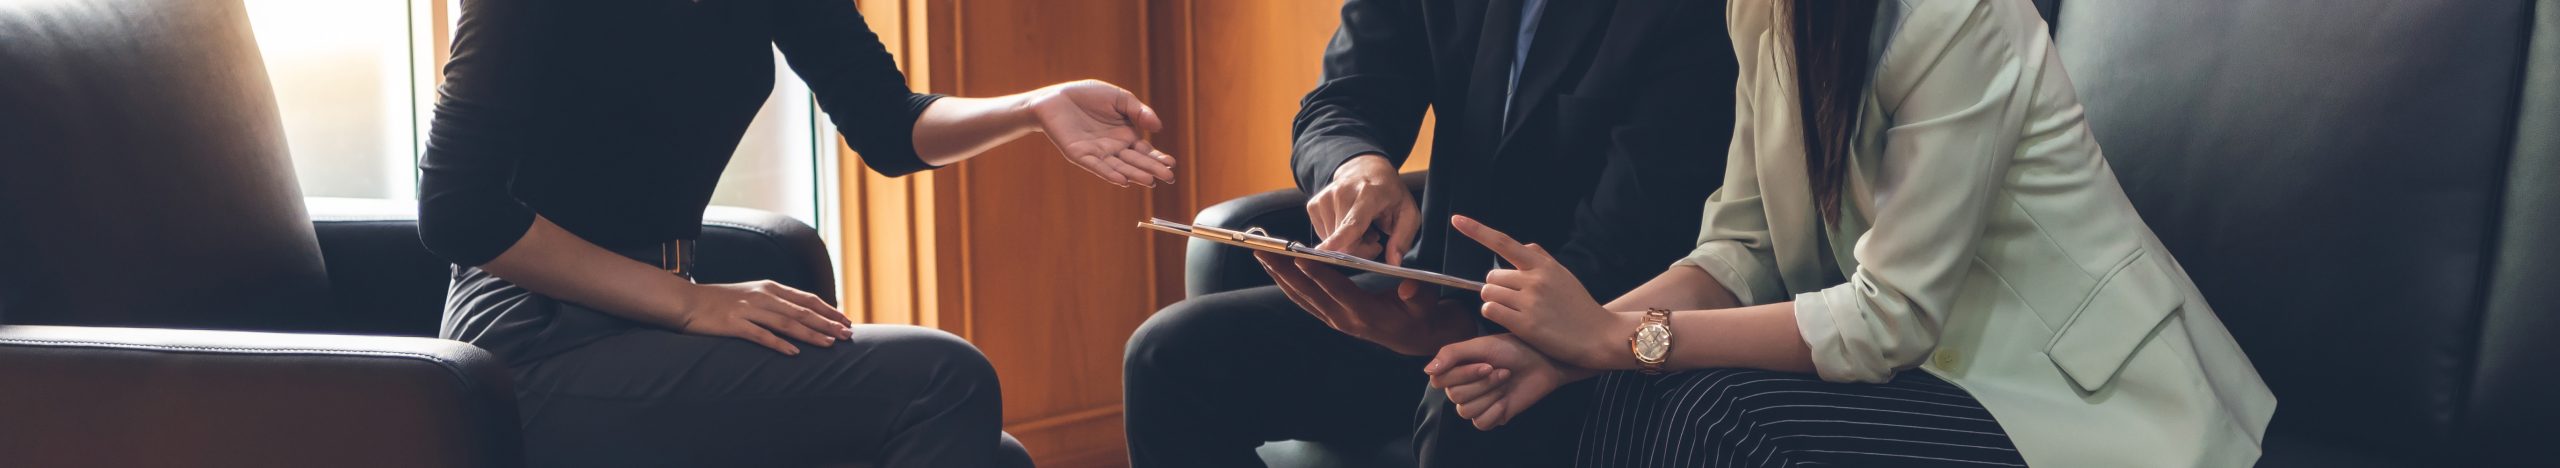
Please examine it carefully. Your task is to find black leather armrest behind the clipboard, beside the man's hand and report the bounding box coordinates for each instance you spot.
[1183,171,1431,297]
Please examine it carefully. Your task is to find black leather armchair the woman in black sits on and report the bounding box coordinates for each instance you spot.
[0,0,835,465]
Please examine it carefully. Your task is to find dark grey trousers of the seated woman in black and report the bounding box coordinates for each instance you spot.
[448,269,1032,468]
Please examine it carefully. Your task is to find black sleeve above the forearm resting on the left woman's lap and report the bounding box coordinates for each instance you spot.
[417,0,548,266]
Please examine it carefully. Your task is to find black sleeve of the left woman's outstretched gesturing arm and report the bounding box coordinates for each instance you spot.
[773,0,942,176]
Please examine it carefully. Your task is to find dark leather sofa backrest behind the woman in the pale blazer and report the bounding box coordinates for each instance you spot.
[2056,0,2560,463]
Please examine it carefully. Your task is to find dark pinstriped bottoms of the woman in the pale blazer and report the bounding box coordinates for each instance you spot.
[1574,368,2025,468]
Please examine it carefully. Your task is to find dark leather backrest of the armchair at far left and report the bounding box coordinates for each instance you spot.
[0,0,328,327]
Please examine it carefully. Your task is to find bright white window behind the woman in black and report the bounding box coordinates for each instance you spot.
[246,0,837,230]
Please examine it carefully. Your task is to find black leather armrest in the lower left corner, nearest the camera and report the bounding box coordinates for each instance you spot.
[0,325,522,465]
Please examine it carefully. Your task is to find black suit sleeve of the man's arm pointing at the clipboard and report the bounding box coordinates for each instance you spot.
[1290,0,1431,192]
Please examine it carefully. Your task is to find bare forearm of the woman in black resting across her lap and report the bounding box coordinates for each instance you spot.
[481,217,694,327]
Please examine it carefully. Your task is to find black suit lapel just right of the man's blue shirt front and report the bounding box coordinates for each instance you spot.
[1487,0,1615,153]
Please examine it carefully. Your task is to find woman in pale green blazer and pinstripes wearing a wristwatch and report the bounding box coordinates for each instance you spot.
[1426,0,2276,465]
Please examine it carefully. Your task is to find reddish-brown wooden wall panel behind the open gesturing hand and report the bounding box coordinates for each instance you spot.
[932,0,1157,465]
